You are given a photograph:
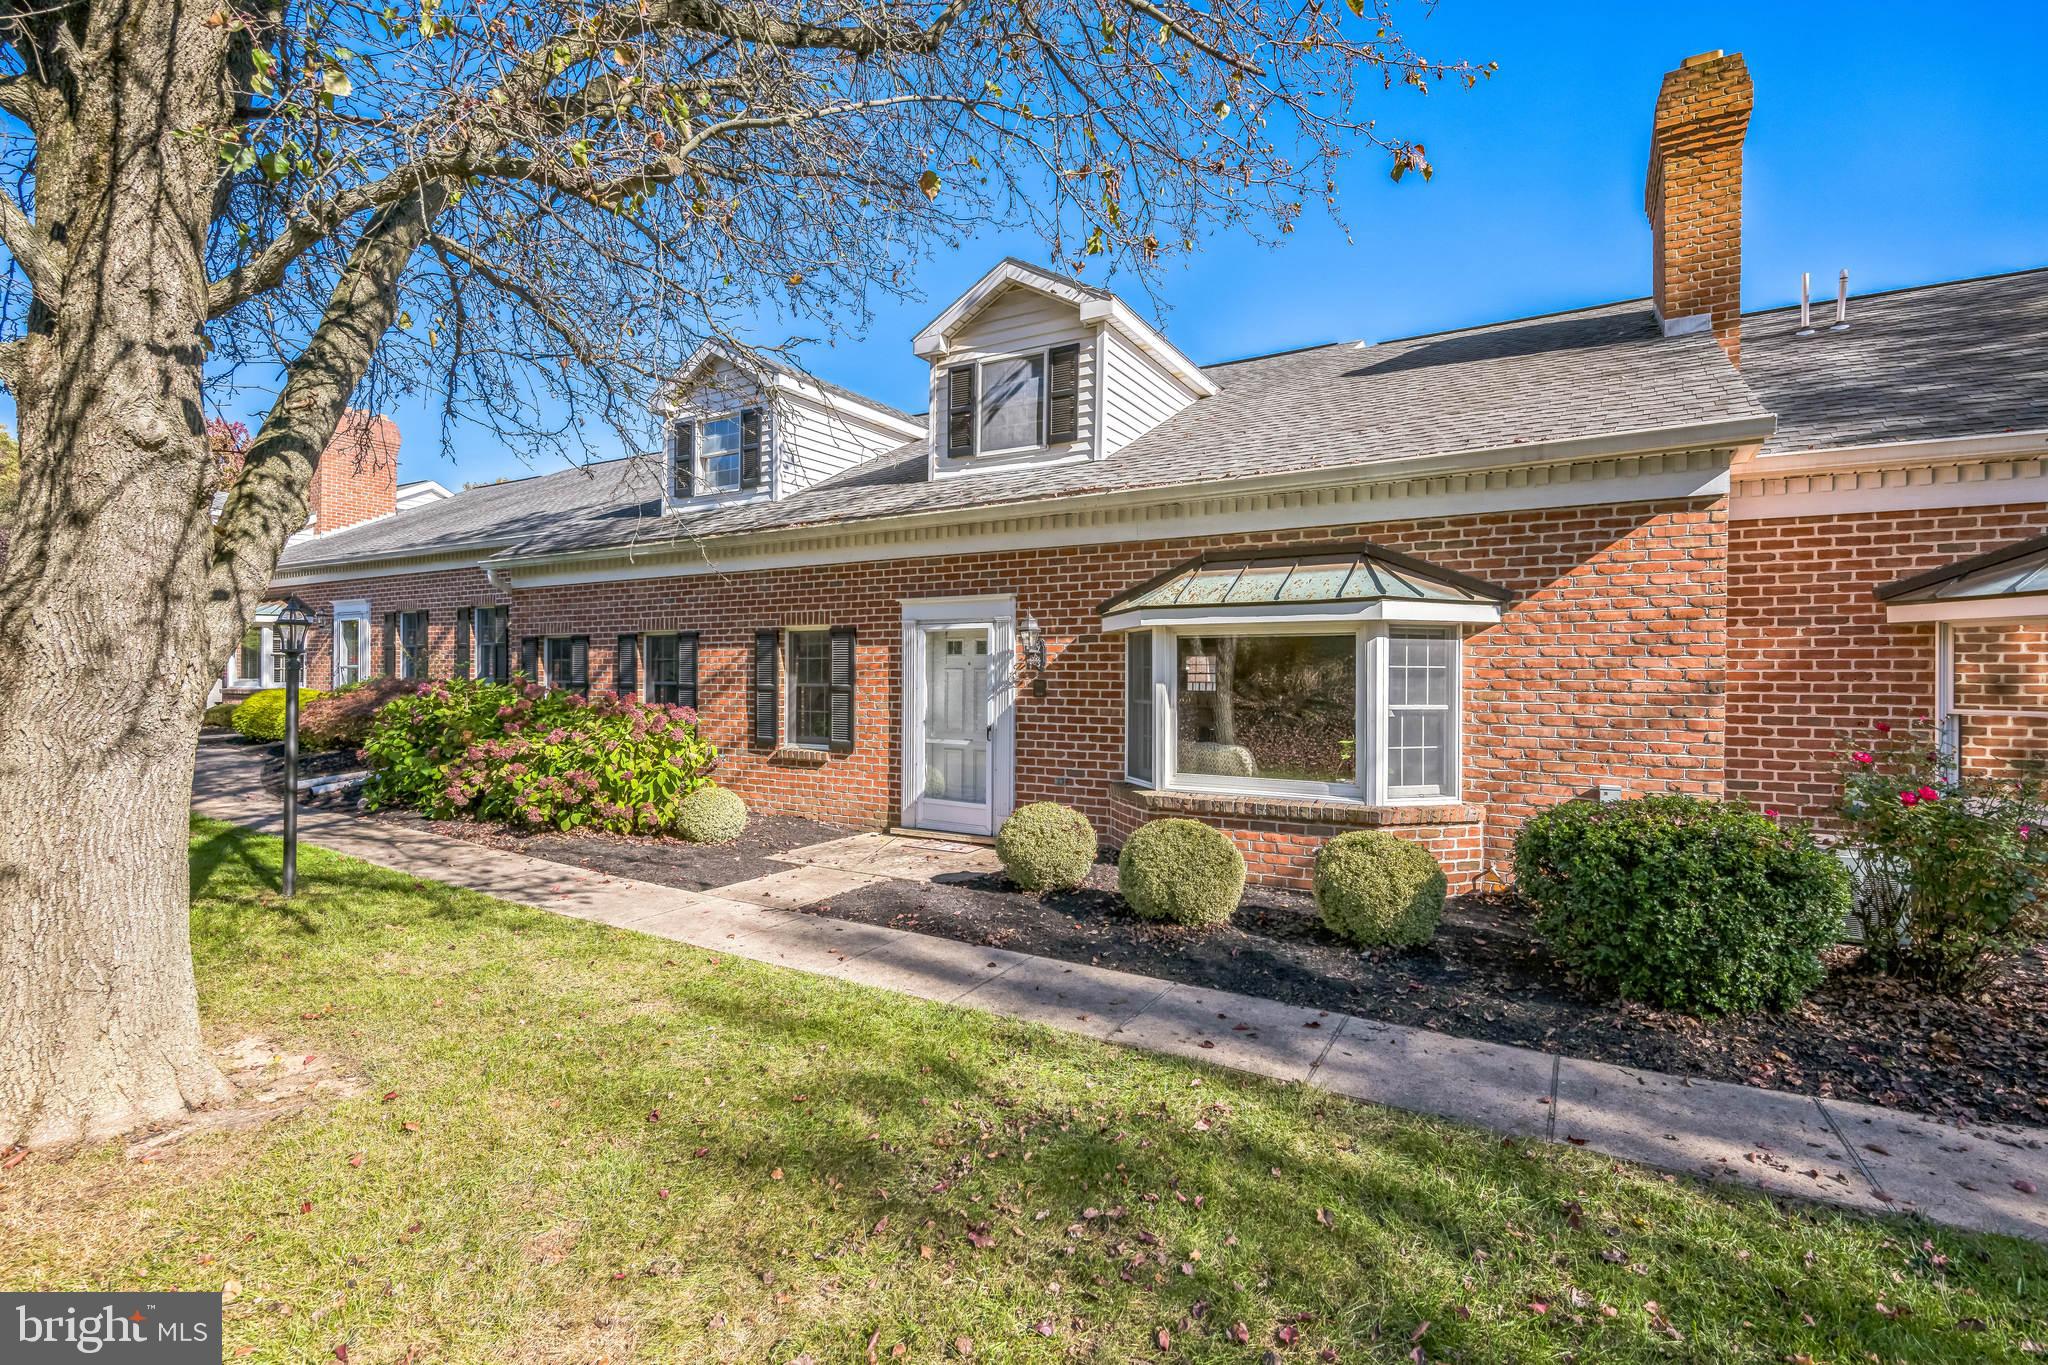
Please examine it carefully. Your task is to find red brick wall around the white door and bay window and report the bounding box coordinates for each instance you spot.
[475,499,1726,880]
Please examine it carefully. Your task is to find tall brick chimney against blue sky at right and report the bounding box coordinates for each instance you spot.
[1642,49,1757,366]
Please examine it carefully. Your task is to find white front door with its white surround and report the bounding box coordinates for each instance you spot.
[903,605,1012,835]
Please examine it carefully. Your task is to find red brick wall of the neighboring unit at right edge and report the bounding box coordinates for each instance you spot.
[1729,503,2048,817]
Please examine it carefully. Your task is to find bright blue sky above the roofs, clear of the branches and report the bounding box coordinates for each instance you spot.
[376,0,2048,487]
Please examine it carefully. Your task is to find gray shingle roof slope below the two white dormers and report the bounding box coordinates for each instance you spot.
[287,301,1769,567]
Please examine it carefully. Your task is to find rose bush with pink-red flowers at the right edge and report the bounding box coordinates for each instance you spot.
[1837,720,2048,993]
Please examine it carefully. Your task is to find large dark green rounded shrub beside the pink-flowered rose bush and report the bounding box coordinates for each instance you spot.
[1516,796,1849,1013]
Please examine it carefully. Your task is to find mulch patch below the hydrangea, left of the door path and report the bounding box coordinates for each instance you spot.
[371,810,854,890]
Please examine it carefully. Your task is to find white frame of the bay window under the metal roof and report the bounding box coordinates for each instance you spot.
[1118,622,1497,806]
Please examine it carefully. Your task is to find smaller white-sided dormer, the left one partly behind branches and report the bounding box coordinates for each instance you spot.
[662,344,924,512]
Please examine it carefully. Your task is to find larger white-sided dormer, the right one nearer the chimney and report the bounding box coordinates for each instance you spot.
[913,260,1217,479]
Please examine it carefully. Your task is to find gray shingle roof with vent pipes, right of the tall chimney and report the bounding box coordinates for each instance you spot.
[1743,270,2048,454]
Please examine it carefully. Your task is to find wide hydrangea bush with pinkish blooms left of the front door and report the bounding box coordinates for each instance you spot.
[362,681,717,835]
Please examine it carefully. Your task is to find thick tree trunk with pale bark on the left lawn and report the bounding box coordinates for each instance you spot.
[0,0,227,1146]
